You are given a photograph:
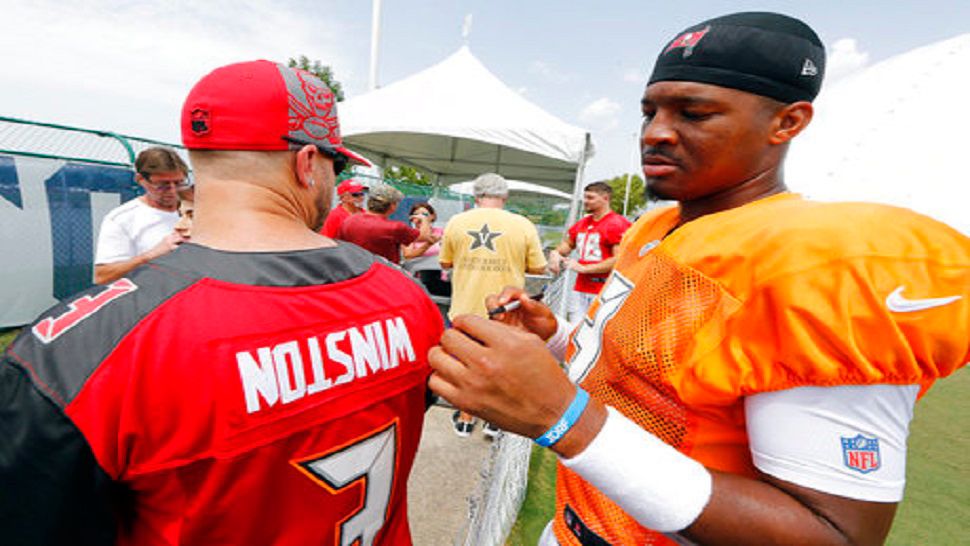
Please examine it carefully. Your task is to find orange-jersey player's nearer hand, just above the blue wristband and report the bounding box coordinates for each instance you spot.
[428,315,576,438]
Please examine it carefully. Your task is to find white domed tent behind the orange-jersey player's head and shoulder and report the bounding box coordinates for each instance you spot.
[786,34,970,234]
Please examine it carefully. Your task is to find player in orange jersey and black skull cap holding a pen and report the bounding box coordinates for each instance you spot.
[430,9,970,546]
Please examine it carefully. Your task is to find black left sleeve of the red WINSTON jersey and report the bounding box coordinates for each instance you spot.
[0,355,117,546]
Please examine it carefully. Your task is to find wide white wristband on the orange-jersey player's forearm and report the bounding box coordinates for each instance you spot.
[560,406,712,533]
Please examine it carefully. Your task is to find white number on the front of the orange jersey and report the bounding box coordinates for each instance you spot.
[568,271,633,385]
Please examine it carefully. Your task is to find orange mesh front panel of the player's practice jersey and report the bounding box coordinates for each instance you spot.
[554,251,750,544]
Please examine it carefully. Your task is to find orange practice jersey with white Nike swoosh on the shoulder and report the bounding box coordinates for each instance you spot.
[554,194,970,545]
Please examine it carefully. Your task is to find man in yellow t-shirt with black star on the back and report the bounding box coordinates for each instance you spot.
[438,173,546,437]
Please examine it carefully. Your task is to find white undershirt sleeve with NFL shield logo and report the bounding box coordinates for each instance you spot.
[745,385,919,502]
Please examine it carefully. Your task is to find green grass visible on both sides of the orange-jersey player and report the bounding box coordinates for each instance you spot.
[508,368,970,546]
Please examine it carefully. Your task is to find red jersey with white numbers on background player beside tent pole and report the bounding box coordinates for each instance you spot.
[569,211,630,294]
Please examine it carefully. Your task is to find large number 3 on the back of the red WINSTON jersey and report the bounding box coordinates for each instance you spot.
[293,422,397,546]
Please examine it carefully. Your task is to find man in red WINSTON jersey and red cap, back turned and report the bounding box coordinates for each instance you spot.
[0,61,442,546]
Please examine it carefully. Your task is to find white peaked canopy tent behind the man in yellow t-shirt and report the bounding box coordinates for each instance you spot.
[340,47,593,200]
